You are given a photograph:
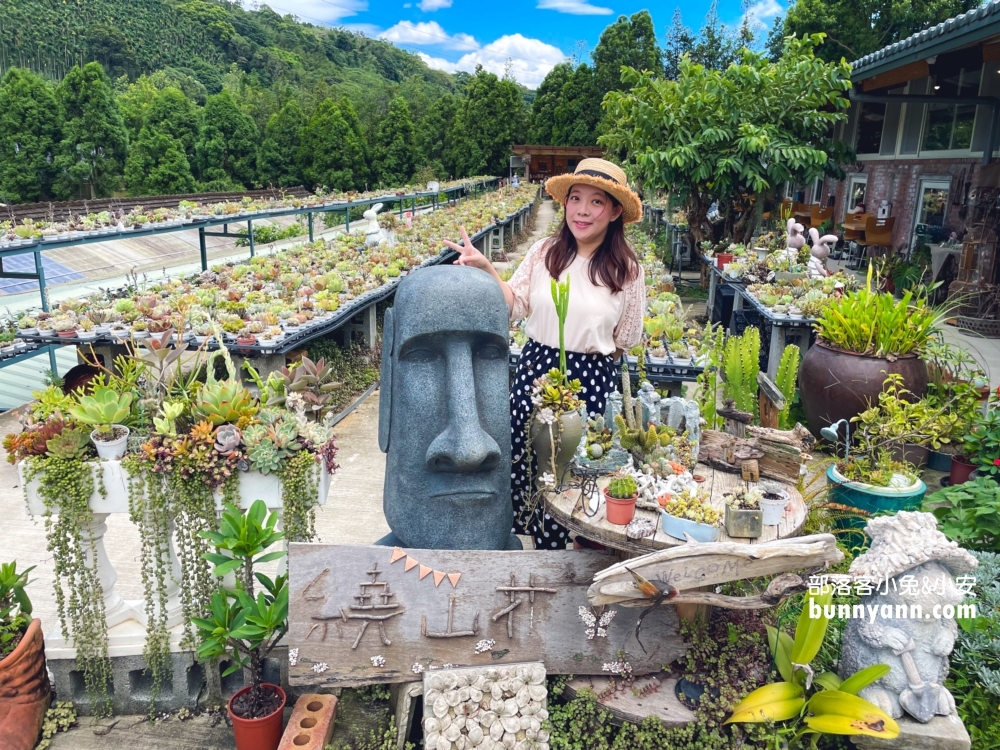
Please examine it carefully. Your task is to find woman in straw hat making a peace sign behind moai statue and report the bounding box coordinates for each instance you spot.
[445,159,646,549]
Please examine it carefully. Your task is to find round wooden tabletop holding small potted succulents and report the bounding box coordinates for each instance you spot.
[545,464,806,555]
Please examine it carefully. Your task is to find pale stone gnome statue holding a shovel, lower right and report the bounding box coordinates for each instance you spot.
[840,511,979,723]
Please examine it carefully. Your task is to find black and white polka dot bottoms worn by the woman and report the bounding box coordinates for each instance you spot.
[510,339,618,549]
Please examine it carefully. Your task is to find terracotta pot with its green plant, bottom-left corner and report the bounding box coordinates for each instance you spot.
[0,562,52,750]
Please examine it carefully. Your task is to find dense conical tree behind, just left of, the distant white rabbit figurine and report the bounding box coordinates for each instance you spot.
[299,99,367,190]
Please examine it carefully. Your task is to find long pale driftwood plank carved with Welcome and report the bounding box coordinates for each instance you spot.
[588,534,844,608]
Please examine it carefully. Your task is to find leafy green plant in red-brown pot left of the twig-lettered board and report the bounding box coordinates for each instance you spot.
[192,500,288,750]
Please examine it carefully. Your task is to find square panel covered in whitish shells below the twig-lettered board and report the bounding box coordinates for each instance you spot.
[424,663,549,750]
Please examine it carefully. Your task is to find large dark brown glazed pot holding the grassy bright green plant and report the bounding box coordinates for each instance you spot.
[799,341,927,437]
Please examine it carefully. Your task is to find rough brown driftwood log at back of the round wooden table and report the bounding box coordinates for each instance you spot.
[698,427,803,485]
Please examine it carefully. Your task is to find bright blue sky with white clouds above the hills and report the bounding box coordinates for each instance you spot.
[254,0,785,88]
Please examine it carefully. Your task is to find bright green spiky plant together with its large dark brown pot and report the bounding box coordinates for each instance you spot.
[799,267,944,437]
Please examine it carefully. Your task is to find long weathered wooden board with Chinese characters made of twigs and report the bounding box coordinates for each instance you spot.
[287,544,687,686]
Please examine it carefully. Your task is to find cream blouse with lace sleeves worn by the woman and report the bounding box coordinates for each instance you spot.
[508,238,646,354]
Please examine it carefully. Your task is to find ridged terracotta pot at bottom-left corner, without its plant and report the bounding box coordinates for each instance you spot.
[0,620,52,750]
